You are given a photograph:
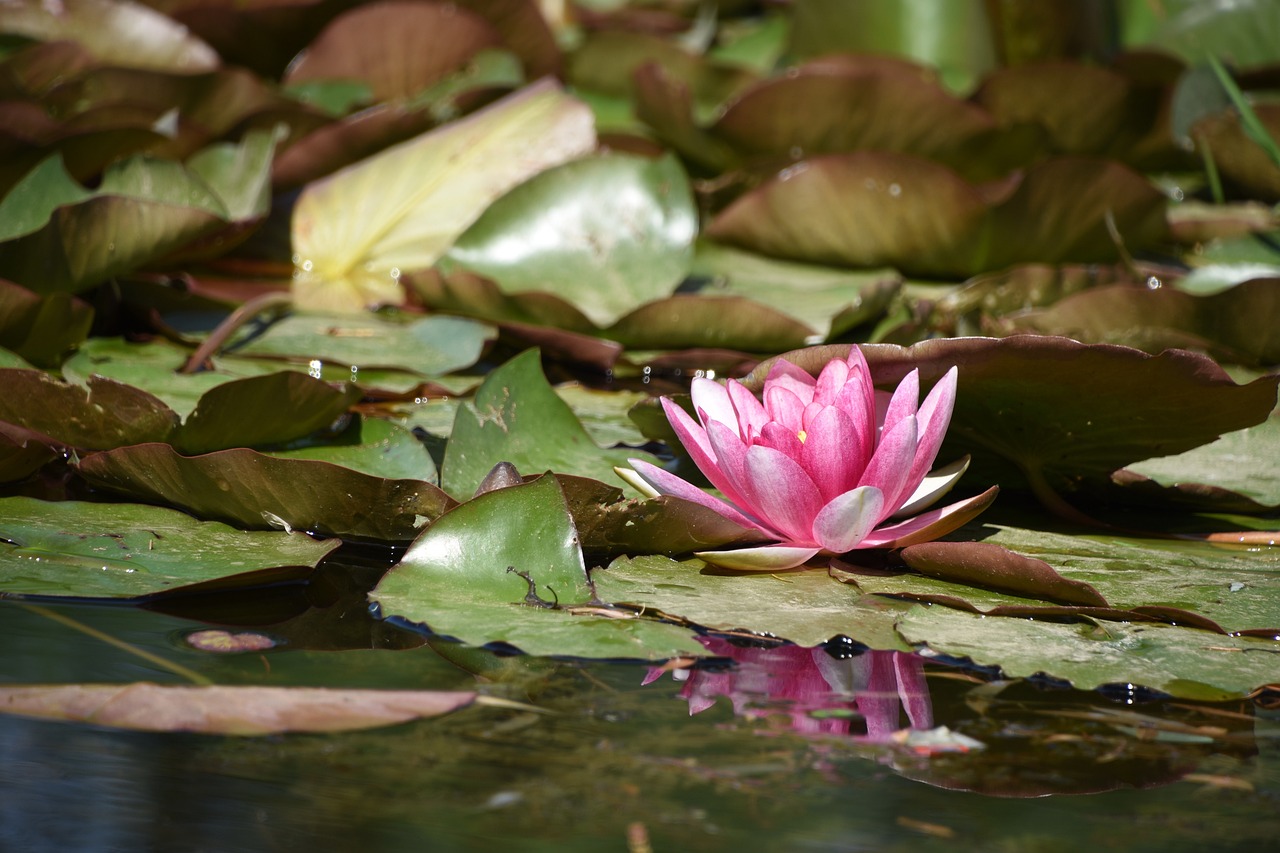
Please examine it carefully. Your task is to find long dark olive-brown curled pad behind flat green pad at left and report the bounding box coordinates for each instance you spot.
[77,443,453,542]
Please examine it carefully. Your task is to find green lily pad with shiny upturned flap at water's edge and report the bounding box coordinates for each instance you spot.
[370,476,704,660]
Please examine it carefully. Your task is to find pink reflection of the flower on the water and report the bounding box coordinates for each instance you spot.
[645,637,933,743]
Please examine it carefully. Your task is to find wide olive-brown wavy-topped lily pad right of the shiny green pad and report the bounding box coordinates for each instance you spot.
[705,151,1167,278]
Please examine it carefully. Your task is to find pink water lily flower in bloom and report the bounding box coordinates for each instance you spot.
[618,347,996,571]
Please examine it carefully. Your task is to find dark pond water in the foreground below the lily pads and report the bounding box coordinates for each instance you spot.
[0,555,1280,853]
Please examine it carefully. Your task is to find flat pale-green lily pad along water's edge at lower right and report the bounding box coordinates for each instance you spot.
[897,607,1280,701]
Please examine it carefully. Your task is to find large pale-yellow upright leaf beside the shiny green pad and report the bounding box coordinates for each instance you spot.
[293,81,595,311]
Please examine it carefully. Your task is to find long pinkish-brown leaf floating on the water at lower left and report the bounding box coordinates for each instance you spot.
[0,683,481,735]
